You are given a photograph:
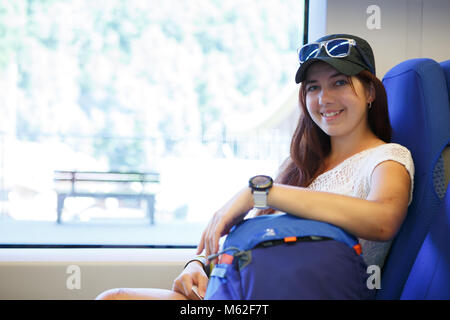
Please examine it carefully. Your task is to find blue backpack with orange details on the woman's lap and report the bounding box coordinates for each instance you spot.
[205,214,373,300]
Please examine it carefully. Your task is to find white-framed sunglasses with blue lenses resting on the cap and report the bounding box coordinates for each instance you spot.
[297,38,374,73]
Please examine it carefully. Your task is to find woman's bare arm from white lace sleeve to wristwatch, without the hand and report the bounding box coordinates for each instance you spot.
[268,161,411,241]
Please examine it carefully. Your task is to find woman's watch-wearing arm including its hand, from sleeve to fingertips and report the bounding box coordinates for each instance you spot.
[198,161,411,256]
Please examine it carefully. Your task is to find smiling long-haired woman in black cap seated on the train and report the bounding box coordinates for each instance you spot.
[96,34,414,299]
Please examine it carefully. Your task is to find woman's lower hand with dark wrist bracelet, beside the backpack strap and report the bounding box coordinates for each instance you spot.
[172,261,208,300]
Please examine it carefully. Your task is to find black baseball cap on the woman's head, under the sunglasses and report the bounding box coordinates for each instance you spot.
[295,34,376,83]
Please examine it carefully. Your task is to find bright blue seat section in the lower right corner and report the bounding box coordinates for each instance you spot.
[401,185,450,300]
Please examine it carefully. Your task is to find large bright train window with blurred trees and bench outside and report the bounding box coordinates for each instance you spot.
[0,0,304,246]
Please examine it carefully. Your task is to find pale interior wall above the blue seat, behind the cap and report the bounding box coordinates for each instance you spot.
[309,0,450,79]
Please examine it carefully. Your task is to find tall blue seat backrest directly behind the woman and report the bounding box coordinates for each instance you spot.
[377,59,450,299]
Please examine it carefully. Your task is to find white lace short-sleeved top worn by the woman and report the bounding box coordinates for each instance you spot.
[308,143,414,268]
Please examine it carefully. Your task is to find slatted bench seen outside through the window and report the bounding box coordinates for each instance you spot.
[54,171,159,225]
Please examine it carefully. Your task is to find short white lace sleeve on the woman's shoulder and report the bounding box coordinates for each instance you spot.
[367,143,414,205]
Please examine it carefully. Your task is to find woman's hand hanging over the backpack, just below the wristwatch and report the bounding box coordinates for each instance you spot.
[197,187,254,257]
